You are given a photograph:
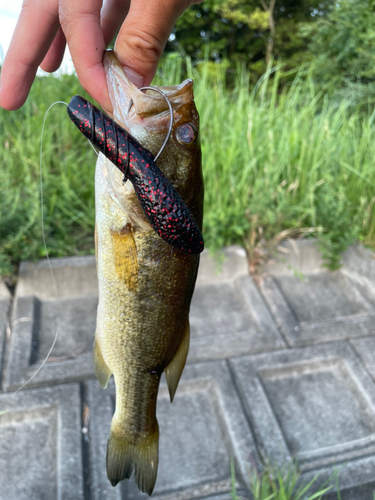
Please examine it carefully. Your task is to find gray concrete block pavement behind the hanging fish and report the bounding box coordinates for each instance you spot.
[0,240,375,500]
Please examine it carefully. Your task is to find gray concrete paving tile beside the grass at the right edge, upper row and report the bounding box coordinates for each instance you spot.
[260,240,375,346]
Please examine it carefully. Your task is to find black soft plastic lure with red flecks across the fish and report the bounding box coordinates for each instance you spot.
[68,95,204,254]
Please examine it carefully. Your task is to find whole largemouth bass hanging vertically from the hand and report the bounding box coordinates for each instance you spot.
[94,52,203,495]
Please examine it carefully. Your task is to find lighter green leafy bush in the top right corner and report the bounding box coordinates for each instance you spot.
[306,0,375,84]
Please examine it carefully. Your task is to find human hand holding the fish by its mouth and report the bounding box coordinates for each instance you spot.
[0,0,202,112]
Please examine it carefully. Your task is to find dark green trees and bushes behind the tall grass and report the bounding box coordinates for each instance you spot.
[167,0,375,89]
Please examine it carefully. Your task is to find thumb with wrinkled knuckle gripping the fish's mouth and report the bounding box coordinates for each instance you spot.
[115,0,193,87]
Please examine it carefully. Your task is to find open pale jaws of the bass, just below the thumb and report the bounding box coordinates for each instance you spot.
[103,50,194,132]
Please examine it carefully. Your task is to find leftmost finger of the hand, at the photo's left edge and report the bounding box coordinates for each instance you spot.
[0,0,58,110]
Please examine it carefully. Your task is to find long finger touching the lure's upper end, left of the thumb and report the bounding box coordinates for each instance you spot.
[60,0,112,112]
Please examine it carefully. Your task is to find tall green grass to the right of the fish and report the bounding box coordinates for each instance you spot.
[192,62,375,268]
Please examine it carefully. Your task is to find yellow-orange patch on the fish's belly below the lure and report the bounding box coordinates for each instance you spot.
[111,224,138,292]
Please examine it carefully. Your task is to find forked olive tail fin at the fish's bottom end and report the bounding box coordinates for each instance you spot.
[107,424,159,495]
